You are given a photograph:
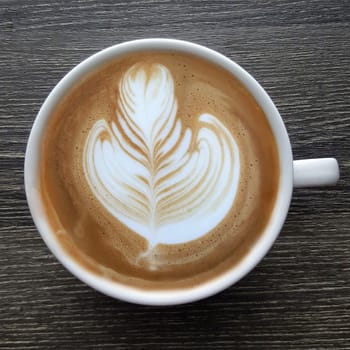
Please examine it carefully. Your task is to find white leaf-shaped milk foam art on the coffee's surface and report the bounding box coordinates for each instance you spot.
[83,63,240,247]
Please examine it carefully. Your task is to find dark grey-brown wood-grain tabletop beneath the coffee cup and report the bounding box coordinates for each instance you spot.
[0,0,350,349]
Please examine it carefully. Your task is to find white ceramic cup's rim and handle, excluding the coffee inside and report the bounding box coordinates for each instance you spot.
[25,39,339,305]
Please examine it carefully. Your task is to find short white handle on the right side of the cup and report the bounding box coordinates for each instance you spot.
[293,158,339,187]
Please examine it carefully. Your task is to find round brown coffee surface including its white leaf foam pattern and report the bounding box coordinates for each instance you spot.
[40,51,279,289]
